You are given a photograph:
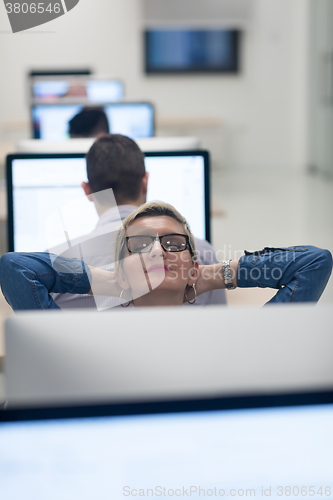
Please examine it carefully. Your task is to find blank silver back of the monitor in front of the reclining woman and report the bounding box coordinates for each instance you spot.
[4,305,333,407]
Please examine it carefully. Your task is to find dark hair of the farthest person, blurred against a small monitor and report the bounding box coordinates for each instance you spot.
[69,108,110,137]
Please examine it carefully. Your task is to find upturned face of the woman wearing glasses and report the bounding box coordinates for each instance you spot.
[119,215,196,299]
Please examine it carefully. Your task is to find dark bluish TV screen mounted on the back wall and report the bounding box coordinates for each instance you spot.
[145,29,240,73]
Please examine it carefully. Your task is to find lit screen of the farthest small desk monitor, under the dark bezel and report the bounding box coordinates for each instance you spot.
[31,75,124,104]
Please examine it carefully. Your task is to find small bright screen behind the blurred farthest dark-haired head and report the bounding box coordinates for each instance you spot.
[31,102,155,141]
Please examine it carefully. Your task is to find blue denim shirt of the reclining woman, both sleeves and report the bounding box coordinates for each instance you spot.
[0,246,332,311]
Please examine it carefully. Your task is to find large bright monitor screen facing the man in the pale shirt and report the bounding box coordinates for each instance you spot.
[7,151,210,252]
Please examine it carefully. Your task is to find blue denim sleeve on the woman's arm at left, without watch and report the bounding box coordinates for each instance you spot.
[0,252,90,311]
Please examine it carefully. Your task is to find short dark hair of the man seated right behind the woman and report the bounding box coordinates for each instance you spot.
[86,134,146,205]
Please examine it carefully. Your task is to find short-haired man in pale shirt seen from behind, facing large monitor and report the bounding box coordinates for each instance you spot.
[52,134,226,310]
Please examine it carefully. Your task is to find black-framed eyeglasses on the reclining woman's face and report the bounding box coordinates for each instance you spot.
[125,233,192,253]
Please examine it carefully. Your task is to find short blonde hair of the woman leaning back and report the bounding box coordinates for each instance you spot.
[115,201,197,266]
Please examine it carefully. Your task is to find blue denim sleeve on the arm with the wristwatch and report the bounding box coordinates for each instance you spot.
[238,246,332,304]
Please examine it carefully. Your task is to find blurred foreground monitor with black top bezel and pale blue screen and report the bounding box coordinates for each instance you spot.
[0,392,333,500]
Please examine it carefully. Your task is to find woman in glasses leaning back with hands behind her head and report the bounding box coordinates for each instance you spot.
[0,202,332,310]
